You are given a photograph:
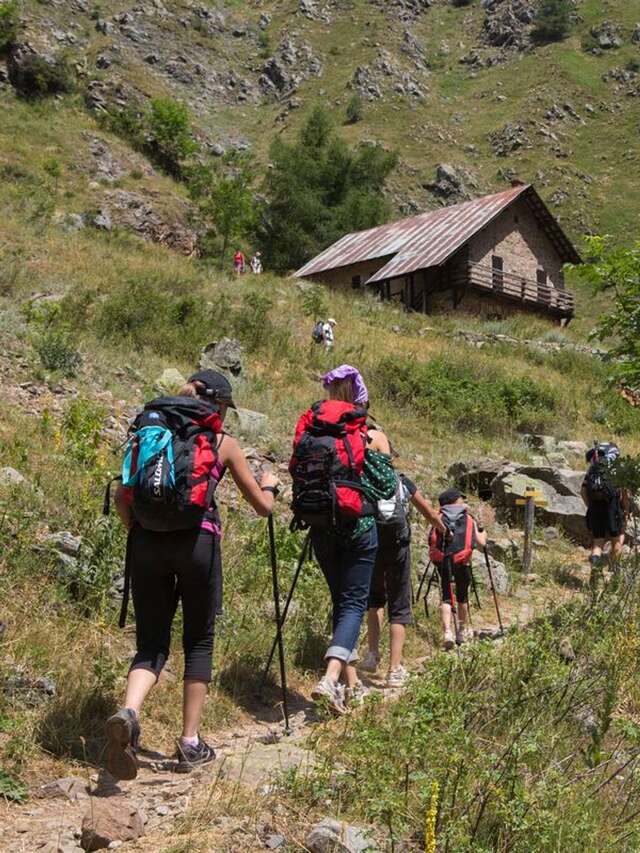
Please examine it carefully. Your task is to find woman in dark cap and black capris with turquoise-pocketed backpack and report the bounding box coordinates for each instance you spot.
[106,370,278,779]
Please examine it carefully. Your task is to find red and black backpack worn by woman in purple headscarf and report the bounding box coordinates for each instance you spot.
[289,400,373,529]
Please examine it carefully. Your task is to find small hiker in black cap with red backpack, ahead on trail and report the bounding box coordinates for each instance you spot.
[429,489,487,650]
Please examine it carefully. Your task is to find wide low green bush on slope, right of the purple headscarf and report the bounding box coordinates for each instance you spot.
[374,357,558,434]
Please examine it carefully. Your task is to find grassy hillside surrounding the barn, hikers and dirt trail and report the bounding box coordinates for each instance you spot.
[0,0,640,853]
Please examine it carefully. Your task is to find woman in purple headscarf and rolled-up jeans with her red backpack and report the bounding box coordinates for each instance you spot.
[289,364,390,714]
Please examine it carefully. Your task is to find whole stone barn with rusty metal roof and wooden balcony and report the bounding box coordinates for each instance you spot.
[295,183,580,323]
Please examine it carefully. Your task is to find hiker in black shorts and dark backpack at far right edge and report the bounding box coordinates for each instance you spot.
[581,443,629,592]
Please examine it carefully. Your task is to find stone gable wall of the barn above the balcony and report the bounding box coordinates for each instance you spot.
[469,199,564,290]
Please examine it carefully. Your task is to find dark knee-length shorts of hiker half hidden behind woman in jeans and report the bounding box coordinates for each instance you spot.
[369,527,413,625]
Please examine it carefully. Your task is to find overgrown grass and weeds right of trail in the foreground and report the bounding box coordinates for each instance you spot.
[286,592,640,853]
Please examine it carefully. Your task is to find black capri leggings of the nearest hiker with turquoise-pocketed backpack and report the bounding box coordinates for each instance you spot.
[129,526,222,682]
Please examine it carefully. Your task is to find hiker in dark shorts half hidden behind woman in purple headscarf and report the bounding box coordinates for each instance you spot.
[360,470,447,687]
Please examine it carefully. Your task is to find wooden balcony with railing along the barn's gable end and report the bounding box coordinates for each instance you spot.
[455,263,575,318]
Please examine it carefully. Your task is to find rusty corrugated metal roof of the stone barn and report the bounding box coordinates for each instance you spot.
[294,184,579,283]
